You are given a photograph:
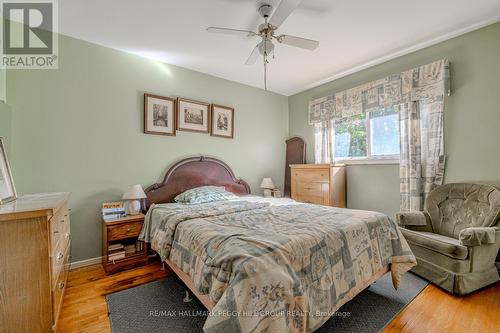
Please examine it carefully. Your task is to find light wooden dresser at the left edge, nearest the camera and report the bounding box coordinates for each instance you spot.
[0,193,71,333]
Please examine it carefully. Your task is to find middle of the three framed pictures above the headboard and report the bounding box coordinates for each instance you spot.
[177,98,210,133]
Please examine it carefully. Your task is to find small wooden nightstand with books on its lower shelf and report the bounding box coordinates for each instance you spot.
[102,214,148,274]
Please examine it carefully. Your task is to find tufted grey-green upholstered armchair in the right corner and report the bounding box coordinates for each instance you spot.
[397,184,500,295]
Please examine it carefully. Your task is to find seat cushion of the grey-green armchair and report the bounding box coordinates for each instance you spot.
[401,228,469,260]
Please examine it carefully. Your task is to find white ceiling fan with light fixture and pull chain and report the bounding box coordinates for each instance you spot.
[207,0,319,90]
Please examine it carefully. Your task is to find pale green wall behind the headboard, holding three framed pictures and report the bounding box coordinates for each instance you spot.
[7,36,288,261]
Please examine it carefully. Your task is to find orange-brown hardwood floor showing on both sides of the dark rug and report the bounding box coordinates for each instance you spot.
[58,264,500,333]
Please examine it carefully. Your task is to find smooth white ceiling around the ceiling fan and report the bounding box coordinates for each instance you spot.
[59,0,500,95]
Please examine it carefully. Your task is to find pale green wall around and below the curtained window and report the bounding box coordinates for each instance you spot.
[288,23,500,215]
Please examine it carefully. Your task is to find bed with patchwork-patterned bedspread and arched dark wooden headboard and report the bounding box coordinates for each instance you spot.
[140,157,416,332]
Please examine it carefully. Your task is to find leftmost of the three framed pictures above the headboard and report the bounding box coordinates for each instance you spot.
[144,94,176,135]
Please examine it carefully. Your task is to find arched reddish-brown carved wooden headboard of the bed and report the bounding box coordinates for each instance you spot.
[143,156,250,211]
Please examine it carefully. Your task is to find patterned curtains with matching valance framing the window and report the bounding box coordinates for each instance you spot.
[309,59,450,211]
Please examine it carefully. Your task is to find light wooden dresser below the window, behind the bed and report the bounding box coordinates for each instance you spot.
[290,164,346,208]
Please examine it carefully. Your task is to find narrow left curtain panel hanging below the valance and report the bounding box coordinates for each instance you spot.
[314,119,335,164]
